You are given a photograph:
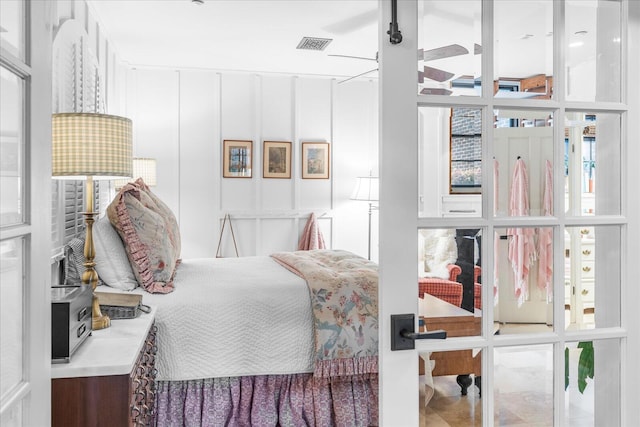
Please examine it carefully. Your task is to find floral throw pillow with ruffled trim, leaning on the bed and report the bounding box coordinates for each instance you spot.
[107,179,180,293]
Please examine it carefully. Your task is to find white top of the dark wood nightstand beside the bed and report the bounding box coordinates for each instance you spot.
[51,307,156,379]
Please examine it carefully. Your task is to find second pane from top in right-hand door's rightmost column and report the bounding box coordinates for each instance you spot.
[564,111,622,215]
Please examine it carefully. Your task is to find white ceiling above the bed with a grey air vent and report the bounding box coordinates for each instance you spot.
[88,0,378,76]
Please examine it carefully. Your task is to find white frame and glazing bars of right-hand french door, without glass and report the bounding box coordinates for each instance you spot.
[379,0,640,426]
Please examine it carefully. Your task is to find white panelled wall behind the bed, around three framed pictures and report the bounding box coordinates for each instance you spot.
[126,69,378,259]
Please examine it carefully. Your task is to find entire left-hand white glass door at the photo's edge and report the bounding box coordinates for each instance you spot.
[0,0,53,427]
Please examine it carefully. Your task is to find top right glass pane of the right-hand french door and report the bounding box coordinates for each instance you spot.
[565,0,622,102]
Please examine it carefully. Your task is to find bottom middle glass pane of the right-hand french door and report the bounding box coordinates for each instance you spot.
[493,344,552,426]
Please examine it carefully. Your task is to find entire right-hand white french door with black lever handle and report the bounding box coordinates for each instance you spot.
[379,0,640,426]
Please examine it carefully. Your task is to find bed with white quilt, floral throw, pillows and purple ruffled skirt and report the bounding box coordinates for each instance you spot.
[82,180,378,426]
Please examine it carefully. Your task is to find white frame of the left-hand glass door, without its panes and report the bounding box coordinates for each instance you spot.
[0,0,55,426]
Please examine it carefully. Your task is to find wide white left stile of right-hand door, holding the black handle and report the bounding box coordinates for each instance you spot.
[378,0,418,426]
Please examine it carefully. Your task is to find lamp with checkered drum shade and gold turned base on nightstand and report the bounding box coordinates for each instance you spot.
[51,113,133,329]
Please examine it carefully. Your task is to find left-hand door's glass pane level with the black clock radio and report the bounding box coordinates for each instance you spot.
[0,239,24,398]
